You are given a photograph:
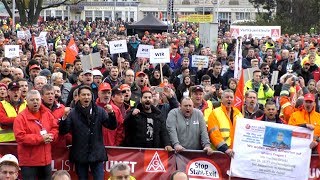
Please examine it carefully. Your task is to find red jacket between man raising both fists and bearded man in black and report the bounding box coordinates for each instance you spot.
[96,98,124,146]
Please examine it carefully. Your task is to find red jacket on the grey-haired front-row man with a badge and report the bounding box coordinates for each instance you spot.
[13,105,58,166]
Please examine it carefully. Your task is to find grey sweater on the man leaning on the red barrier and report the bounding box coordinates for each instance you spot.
[166,108,210,150]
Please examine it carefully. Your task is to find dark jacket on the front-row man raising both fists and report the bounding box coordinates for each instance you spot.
[59,102,117,163]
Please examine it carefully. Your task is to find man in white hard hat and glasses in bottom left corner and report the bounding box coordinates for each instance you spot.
[0,154,20,180]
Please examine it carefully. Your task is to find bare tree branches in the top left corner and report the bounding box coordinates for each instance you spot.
[1,0,82,25]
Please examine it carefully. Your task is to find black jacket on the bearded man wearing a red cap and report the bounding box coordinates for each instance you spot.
[124,103,170,148]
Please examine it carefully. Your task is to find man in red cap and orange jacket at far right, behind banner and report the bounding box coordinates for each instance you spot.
[288,93,320,154]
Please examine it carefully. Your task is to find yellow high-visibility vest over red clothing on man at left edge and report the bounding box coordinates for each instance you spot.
[0,101,27,142]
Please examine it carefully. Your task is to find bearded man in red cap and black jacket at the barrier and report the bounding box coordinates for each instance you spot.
[124,88,173,151]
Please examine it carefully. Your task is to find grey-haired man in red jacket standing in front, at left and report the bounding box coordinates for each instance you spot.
[13,90,58,180]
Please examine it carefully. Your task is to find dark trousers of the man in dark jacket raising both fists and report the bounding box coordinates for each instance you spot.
[75,162,104,180]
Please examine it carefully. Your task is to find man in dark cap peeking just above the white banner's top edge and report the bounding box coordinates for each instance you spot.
[256,101,283,124]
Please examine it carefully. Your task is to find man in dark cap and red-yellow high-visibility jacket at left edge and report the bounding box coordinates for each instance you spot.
[0,82,27,142]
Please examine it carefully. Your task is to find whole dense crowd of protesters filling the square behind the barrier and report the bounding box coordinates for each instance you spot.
[0,17,320,179]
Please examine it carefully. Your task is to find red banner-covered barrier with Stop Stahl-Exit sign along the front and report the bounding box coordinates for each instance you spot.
[0,143,320,180]
